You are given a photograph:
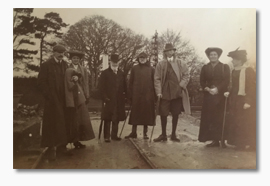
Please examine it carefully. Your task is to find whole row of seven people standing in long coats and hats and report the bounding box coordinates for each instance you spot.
[38,43,256,160]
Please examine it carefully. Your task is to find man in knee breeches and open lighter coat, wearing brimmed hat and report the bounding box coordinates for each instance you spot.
[154,43,190,142]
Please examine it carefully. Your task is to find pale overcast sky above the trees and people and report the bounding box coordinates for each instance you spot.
[33,8,256,63]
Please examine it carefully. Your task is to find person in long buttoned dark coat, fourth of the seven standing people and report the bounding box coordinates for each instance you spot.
[125,52,156,139]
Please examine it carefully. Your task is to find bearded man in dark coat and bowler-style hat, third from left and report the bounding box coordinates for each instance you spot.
[99,54,126,142]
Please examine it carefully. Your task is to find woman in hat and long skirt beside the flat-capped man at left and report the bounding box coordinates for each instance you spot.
[65,51,95,149]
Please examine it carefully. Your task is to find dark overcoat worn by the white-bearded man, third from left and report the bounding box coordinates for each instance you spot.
[98,67,127,121]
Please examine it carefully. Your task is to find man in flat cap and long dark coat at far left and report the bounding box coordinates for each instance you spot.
[38,45,67,160]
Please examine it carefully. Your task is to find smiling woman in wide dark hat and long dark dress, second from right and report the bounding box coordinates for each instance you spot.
[199,48,230,147]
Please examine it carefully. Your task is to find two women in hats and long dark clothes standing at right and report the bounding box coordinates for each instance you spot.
[199,48,256,150]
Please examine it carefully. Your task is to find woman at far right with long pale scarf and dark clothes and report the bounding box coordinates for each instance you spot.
[224,50,256,150]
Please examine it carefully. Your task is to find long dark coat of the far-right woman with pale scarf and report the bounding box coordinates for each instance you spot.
[226,67,256,147]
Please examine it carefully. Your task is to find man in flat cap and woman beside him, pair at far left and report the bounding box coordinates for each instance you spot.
[38,45,95,160]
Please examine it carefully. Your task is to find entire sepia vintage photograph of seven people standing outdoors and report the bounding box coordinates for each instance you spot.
[13,8,258,170]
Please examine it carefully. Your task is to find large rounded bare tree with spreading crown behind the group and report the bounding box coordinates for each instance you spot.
[63,15,147,89]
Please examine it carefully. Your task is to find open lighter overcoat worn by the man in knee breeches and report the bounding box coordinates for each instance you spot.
[154,58,191,114]
